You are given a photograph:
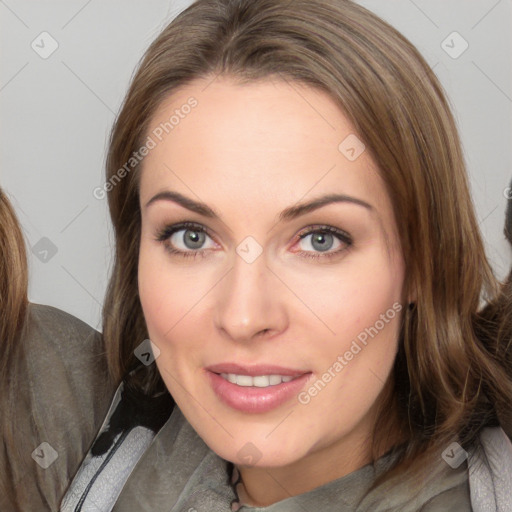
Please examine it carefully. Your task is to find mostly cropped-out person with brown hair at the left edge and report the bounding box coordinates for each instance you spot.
[0,189,114,512]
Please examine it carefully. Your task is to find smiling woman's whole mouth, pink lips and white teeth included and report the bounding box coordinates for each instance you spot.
[205,363,312,414]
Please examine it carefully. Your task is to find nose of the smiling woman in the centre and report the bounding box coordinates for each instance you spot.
[215,254,288,342]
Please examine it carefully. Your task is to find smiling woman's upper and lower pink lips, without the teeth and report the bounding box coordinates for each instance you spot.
[205,363,311,413]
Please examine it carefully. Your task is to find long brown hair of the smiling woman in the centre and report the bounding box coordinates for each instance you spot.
[100,0,512,496]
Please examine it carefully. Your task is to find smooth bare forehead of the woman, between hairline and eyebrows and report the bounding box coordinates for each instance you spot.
[141,77,384,218]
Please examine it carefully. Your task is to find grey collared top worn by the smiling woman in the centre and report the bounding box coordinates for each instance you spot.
[62,380,512,512]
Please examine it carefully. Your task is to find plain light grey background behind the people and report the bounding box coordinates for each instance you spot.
[0,0,512,328]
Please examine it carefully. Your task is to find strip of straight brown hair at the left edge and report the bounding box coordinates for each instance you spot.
[0,188,28,506]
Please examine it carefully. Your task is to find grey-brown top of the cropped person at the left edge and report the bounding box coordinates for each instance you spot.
[0,304,115,512]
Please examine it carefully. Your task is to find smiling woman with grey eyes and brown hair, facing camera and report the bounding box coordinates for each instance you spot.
[62,0,512,512]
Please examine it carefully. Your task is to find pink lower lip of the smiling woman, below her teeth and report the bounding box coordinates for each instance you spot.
[207,371,311,413]
